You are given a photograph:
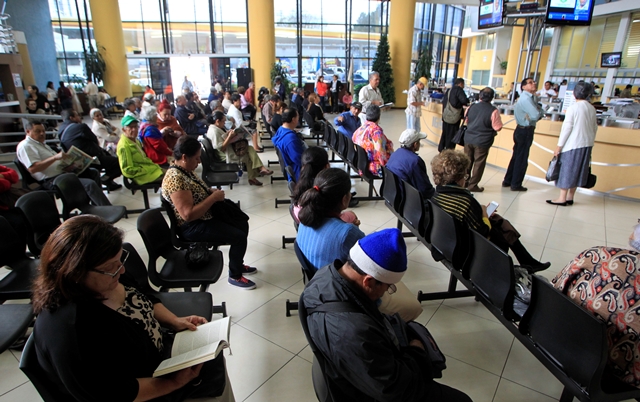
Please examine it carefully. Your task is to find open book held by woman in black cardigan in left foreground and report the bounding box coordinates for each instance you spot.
[153,317,230,377]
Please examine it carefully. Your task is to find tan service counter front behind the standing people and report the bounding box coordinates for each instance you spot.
[422,102,640,200]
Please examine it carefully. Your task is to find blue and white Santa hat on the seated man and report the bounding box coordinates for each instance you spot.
[349,229,407,284]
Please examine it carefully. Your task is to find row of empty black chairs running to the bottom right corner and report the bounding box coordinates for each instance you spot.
[383,166,640,402]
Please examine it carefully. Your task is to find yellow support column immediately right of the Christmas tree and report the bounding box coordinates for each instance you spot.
[385,0,420,108]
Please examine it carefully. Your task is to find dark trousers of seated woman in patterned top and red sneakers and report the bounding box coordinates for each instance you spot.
[180,218,249,279]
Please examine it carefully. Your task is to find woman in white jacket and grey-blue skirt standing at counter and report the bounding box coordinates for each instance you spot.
[547,82,598,207]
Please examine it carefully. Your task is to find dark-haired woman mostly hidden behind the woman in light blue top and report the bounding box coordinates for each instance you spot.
[291,147,360,226]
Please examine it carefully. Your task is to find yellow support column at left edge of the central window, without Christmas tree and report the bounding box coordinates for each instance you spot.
[247,0,276,97]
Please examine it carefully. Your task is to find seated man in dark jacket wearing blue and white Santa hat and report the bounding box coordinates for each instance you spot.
[301,229,471,402]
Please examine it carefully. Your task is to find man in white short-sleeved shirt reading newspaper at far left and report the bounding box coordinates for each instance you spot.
[16,120,111,205]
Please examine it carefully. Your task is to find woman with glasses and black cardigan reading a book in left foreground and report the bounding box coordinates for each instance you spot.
[32,215,233,401]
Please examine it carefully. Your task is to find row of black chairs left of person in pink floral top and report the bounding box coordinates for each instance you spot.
[324,123,383,201]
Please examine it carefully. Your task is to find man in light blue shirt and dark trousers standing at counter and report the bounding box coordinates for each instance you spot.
[502,78,544,191]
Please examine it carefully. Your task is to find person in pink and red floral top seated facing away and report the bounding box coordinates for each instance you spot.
[352,104,393,177]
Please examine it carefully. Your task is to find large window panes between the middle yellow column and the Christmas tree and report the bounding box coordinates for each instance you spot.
[274,0,389,85]
